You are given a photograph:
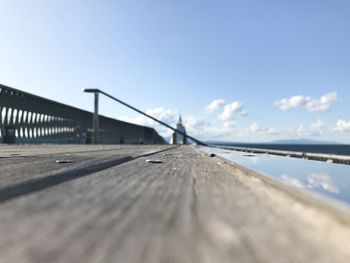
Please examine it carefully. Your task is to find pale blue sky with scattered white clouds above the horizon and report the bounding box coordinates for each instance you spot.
[0,0,350,143]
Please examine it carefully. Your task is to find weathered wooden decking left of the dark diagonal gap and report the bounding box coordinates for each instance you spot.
[0,145,171,189]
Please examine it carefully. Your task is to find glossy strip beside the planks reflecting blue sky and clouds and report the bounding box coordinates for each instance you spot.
[202,147,350,204]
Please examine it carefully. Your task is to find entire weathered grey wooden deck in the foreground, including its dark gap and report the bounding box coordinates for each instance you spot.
[0,146,350,263]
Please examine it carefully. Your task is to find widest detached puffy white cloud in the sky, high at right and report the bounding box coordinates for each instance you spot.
[275,92,337,112]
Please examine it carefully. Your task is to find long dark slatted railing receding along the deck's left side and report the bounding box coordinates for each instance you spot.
[0,84,165,144]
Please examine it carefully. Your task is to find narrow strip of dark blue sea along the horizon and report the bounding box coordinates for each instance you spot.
[209,142,350,156]
